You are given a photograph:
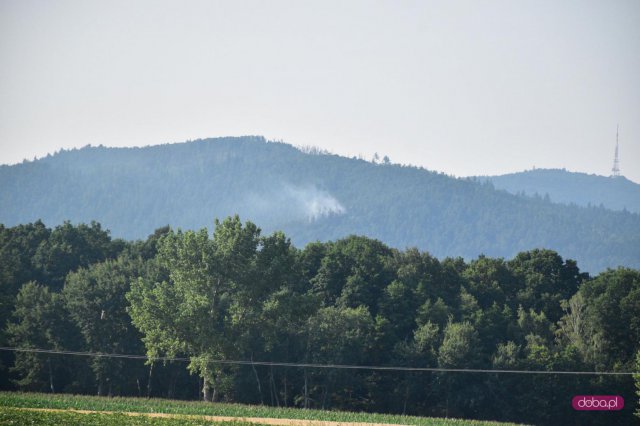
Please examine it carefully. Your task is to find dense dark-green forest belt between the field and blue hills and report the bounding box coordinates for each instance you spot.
[0,218,640,425]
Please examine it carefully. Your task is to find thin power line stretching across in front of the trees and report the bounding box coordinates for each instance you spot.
[0,347,640,376]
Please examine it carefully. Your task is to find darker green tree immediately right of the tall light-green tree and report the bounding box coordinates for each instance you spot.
[229,232,308,405]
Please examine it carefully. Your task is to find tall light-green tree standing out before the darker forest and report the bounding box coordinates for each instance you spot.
[128,216,260,400]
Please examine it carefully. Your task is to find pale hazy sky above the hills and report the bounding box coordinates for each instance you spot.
[0,0,640,182]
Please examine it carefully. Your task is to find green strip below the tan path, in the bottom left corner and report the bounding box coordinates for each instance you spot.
[0,407,256,426]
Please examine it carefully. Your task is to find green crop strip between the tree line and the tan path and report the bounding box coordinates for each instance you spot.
[0,392,513,426]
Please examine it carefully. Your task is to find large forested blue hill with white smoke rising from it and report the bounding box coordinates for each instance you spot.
[0,137,640,273]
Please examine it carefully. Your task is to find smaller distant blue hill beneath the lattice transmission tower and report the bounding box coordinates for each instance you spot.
[478,169,640,213]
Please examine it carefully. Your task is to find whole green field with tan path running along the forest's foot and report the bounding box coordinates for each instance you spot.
[0,392,524,426]
